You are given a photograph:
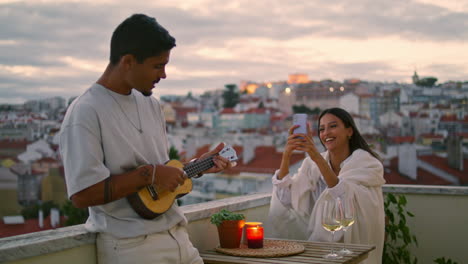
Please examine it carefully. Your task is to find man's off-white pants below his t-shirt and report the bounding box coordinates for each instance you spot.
[96,225,203,264]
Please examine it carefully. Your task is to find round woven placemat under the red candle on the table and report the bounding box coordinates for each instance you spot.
[215,240,304,258]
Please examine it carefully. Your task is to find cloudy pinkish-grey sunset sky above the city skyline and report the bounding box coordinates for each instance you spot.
[0,0,468,103]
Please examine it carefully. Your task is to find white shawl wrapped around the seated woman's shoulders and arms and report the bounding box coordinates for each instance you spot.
[267,149,385,264]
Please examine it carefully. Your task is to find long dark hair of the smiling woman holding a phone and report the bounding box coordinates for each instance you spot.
[317,107,380,160]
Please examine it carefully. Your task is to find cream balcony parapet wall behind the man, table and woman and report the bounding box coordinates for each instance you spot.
[0,185,468,264]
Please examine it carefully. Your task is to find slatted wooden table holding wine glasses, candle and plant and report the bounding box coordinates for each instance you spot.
[200,239,375,264]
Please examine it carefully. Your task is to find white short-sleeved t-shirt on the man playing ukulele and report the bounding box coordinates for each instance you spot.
[60,84,187,238]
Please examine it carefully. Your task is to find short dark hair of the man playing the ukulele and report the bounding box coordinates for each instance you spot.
[110,14,176,65]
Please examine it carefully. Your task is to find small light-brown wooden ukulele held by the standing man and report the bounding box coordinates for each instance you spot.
[127,145,237,219]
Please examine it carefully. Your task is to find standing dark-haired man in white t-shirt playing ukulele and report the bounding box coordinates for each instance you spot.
[60,14,231,263]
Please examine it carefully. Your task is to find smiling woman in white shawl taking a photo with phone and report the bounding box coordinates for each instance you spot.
[269,108,385,263]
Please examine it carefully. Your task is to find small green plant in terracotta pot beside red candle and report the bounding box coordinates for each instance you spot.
[211,209,245,248]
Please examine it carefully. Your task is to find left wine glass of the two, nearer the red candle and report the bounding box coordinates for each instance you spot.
[322,199,343,259]
